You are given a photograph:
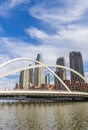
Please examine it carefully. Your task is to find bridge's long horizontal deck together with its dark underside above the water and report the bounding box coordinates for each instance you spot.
[0,90,88,101]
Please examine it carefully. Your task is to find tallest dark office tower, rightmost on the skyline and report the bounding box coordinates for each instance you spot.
[69,51,84,83]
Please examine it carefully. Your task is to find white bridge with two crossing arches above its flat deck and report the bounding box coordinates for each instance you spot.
[0,58,88,100]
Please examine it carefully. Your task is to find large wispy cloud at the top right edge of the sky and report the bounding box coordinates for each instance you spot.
[29,0,88,27]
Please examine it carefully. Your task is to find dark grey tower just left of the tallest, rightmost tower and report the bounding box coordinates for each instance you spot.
[55,57,66,88]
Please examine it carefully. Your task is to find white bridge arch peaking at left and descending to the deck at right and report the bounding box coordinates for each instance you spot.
[0,58,71,92]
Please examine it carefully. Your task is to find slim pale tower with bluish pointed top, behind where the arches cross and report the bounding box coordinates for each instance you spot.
[34,54,44,86]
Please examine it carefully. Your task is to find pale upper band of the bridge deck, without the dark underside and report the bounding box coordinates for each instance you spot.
[0,90,88,97]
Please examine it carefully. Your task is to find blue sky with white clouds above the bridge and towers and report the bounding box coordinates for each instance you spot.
[0,0,88,87]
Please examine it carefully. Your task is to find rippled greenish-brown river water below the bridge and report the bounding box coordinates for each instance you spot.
[0,101,88,130]
